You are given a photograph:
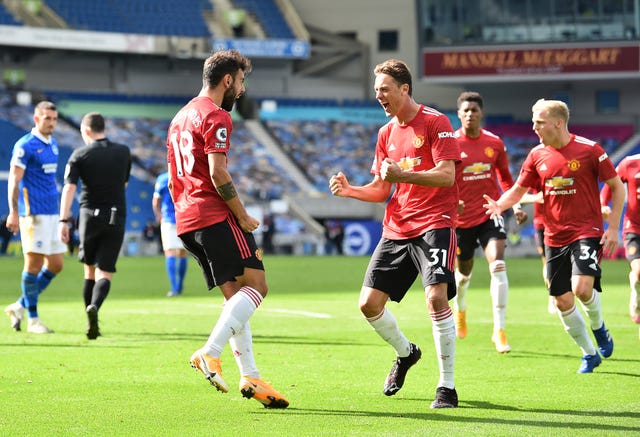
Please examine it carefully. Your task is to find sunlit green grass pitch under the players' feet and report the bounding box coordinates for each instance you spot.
[0,256,640,436]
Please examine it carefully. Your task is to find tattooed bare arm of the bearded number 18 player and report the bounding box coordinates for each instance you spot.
[207,153,260,232]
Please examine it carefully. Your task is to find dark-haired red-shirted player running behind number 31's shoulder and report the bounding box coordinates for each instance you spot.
[454,91,527,353]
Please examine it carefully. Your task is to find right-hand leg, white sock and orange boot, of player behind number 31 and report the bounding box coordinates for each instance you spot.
[484,239,511,353]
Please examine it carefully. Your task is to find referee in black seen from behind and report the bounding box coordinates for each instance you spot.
[59,112,131,340]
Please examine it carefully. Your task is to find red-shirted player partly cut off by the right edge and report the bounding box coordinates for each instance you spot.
[600,154,640,324]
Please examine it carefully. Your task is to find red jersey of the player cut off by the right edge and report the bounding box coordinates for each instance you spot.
[600,154,640,234]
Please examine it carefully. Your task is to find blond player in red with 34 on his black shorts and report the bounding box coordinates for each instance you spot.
[484,99,624,373]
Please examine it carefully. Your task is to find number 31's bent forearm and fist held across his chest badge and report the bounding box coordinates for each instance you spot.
[380,158,456,187]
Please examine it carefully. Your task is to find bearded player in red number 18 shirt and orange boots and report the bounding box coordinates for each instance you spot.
[167,50,289,408]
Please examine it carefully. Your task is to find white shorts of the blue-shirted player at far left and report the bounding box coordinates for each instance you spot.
[20,214,67,255]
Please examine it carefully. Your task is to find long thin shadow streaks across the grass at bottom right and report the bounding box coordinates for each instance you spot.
[272,399,640,433]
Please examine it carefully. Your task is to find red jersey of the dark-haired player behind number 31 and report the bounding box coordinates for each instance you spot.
[456,129,513,228]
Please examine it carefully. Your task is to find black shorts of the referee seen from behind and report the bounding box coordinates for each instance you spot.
[78,208,126,273]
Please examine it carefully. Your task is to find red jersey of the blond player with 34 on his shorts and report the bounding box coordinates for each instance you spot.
[517,135,616,247]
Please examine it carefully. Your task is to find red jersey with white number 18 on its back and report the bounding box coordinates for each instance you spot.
[167,96,232,235]
